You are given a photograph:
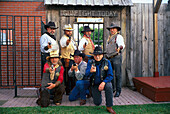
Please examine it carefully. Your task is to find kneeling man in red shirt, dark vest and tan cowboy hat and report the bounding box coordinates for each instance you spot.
[37,51,65,107]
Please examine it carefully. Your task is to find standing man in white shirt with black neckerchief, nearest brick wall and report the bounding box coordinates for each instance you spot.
[40,21,58,70]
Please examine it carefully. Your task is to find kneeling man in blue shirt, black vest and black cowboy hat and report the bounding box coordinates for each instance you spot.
[85,47,115,114]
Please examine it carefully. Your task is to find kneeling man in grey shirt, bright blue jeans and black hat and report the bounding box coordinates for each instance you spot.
[68,50,90,105]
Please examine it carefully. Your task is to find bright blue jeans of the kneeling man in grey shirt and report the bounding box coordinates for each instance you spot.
[69,80,90,101]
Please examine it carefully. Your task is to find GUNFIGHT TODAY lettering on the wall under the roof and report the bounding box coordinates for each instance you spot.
[60,10,118,17]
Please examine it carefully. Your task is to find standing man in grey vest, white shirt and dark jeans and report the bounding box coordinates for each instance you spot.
[106,23,125,97]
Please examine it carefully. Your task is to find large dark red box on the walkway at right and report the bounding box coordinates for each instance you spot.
[133,76,170,102]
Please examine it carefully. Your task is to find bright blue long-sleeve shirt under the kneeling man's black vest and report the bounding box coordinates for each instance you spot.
[85,59,113,85]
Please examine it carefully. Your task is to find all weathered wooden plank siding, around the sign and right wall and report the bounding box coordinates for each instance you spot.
[46,4,170,85]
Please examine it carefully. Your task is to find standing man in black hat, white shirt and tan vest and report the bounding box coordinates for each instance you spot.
[78,26,95,62]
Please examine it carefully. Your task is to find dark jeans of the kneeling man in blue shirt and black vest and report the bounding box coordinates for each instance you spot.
[91,82,113,107]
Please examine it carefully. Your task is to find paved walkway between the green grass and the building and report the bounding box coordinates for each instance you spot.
[0,88,170,107]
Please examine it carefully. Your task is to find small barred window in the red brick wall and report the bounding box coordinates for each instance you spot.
[0,29,13,45]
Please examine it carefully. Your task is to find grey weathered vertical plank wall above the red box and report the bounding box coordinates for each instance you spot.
[129,4,170,77]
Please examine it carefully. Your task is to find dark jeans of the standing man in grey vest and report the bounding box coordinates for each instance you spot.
[109,55,122,92]
